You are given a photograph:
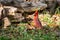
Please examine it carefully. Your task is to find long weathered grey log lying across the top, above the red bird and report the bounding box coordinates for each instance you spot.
[0,0,47,12]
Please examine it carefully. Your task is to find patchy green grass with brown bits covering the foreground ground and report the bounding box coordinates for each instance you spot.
[0,26,57,40]
